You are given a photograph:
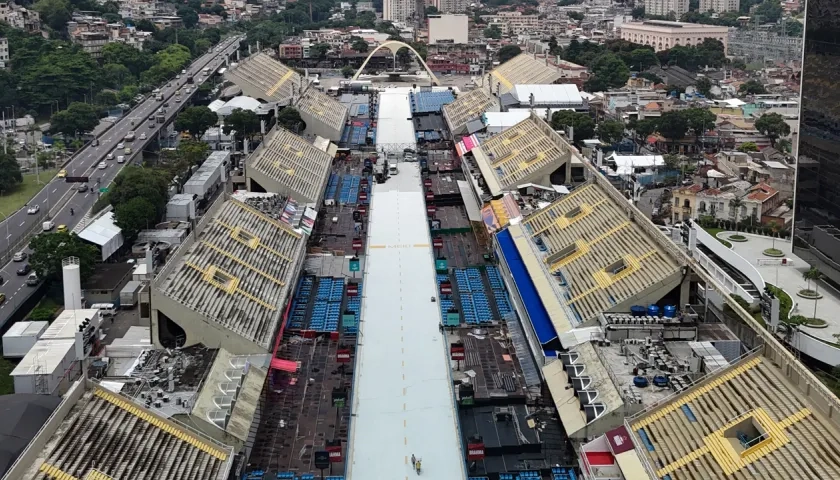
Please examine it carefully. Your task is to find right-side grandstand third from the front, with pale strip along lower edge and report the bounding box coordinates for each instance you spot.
[472,114,571,195]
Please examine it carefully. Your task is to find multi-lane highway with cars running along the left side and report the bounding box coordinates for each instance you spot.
[0,36,244,327]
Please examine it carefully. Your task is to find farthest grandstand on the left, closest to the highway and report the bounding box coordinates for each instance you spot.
[225,53,302,104]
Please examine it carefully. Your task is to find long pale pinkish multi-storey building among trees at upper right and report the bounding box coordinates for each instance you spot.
[621,20,729,52]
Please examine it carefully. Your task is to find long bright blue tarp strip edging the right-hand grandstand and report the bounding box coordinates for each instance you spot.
[496,229,557,345]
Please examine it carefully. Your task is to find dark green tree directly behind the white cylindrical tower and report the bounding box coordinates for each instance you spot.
[29,232,99,281]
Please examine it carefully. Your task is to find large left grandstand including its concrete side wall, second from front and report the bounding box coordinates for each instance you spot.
[152,199,305,354]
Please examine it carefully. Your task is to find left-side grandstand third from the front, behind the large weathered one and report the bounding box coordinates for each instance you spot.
[246,127,332,202]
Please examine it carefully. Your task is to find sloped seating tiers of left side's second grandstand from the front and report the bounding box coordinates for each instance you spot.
[159,199,305,349]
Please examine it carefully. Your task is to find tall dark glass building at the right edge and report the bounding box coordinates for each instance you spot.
[794,0,840,283]
